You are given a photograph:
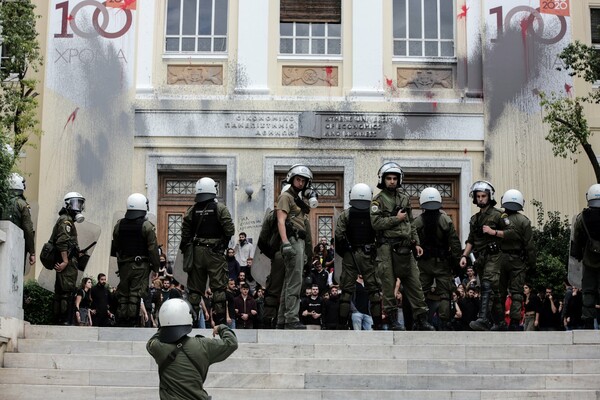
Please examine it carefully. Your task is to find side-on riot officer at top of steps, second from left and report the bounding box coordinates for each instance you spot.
[50,192,85,325]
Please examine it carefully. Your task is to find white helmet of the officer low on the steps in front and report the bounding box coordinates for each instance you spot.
[158,299,193,343]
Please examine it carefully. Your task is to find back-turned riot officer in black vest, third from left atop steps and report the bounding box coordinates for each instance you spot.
[111,193,160,326]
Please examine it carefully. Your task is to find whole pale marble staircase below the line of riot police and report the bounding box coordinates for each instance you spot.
[0,325,600,400]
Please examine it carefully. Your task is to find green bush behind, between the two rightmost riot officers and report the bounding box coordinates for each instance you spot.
[526,200,571,296]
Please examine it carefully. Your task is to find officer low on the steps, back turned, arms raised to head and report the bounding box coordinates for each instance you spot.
[146,299,238,400]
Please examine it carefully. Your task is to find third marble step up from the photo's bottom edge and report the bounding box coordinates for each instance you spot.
[4,351,600,375]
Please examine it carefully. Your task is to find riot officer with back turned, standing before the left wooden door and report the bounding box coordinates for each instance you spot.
[179,177,235,324]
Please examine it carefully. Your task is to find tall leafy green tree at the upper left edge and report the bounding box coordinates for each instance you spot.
[0,0,42,211]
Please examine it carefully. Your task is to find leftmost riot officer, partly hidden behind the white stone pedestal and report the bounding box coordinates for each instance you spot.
[2,172,35,265]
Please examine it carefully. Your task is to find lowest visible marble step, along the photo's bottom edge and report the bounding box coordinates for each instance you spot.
[0,383,600,400]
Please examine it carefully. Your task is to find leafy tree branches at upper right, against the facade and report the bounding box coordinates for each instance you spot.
[540,41,600,182]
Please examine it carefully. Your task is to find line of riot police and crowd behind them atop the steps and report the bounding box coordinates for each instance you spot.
[3,162,600,331]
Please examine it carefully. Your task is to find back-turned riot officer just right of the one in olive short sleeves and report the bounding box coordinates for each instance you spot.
[335,183,381,329]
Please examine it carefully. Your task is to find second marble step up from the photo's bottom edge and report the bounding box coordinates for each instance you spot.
[0,368,600,390]
